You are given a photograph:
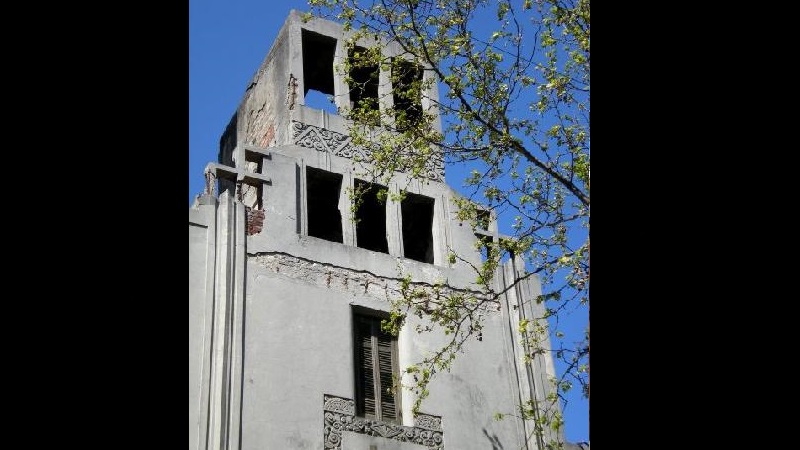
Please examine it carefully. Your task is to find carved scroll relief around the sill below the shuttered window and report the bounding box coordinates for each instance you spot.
[322,395,444,450]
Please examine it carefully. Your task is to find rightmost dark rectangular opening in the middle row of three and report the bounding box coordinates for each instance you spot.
[400,193,434,264]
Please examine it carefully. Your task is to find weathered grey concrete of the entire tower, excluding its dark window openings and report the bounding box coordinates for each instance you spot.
[189,8,556,450]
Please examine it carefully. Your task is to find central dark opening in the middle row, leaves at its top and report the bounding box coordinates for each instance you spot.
[355,180,389,253]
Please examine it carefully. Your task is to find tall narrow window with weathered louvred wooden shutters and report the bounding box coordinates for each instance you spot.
[353,310,402,423]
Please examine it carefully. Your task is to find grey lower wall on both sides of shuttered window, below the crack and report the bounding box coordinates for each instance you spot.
[242,251,524,449]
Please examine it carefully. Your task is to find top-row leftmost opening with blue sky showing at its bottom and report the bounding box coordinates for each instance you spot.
[302,29,336,114]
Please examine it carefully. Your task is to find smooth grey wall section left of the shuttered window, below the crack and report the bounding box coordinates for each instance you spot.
[242,258,353,449]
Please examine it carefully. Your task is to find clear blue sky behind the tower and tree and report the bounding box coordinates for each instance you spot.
[188,0,589,442]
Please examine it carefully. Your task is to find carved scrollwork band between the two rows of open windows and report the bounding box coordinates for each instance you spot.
[292,121,444,183]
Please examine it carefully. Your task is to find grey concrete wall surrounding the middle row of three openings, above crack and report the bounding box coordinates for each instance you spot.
[247,145,488,287]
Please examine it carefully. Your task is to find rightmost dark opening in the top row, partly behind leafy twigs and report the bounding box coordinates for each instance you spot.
[392,58,422,131]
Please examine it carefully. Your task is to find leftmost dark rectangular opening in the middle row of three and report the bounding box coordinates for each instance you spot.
[306,167,343,243]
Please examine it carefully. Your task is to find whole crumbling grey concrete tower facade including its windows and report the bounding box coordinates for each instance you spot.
[189,11,558,450]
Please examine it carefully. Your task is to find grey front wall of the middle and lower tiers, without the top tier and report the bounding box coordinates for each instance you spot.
[228,142,546,449]
